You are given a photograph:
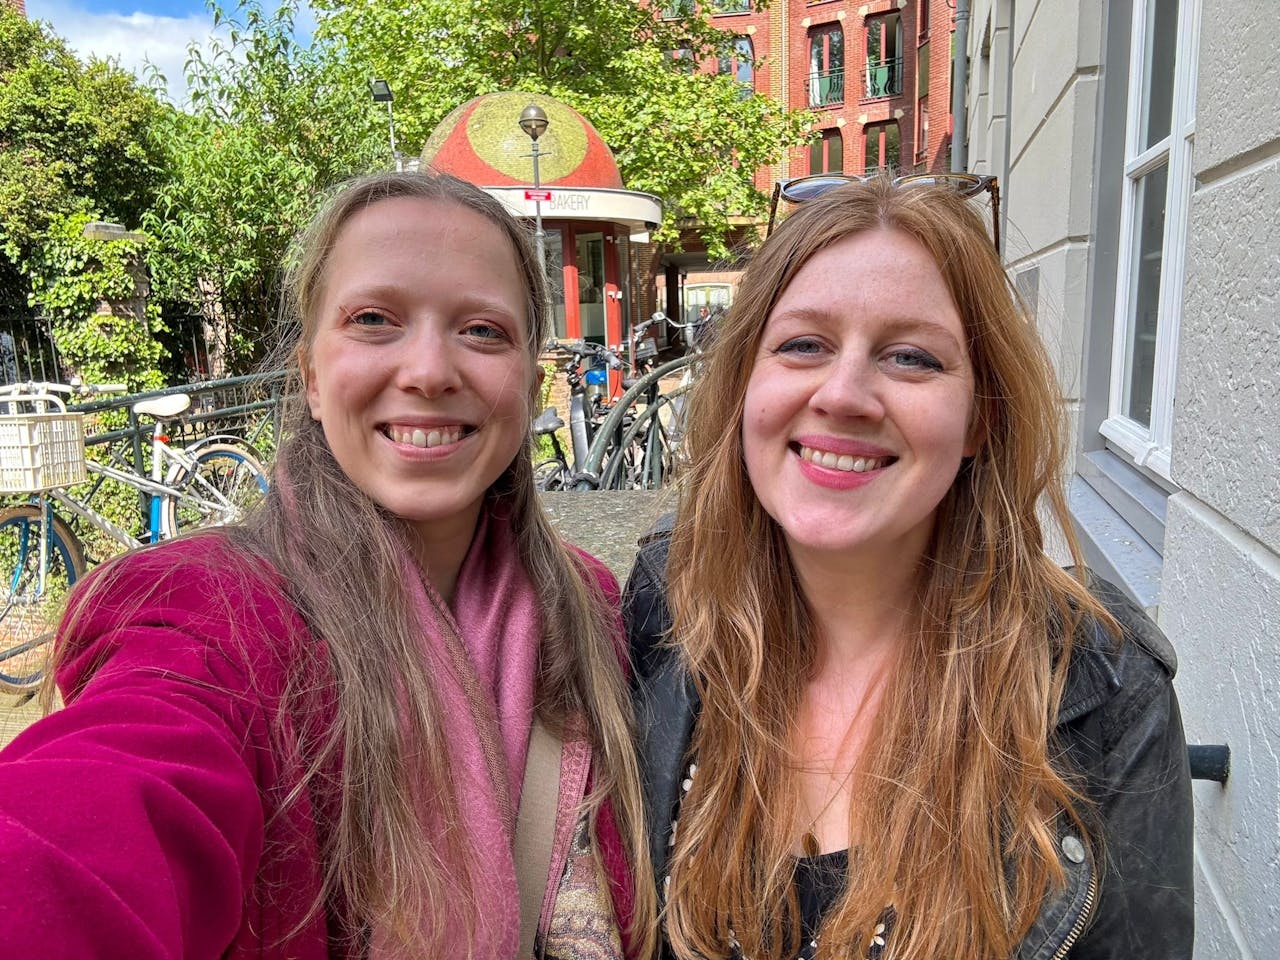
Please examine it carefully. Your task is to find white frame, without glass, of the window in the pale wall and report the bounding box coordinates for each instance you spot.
[1100,0,1201,480]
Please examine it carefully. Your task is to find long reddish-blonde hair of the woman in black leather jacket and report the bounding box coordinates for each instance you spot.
[666,179,1114,960]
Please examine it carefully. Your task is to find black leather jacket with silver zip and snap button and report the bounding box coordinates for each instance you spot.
[623,531,1194,960]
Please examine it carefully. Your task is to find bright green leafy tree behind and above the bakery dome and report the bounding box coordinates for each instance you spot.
[314,0,808,257]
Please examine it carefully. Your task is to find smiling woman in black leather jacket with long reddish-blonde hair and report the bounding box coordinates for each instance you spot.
[625,178,1193,960]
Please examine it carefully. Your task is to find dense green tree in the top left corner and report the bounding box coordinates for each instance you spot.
[0,4,166,378]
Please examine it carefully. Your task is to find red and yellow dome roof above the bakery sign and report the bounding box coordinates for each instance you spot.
[422,91,622,189]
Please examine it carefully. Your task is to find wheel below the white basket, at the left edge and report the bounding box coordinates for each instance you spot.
[0,503,84,691]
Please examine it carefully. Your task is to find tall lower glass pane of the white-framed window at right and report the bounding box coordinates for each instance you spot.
[1123,166,1169,428]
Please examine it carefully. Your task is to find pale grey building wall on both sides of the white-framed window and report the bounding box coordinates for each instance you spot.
[966,0,1280,960]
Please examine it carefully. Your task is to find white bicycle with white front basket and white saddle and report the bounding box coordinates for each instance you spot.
[0,381,266,691]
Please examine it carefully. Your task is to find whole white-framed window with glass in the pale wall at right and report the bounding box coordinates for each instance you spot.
[1101,0,1198,480]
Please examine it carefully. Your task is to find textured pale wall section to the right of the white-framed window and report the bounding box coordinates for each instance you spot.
[1160,0,1280,960]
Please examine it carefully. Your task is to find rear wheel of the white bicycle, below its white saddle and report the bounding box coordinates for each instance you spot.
[160,443,266,538]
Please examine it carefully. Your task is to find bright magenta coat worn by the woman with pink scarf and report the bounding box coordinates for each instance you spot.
[0,535,632,960]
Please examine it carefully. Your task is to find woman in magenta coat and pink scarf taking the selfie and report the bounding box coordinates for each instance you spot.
[0,174,654,960]
